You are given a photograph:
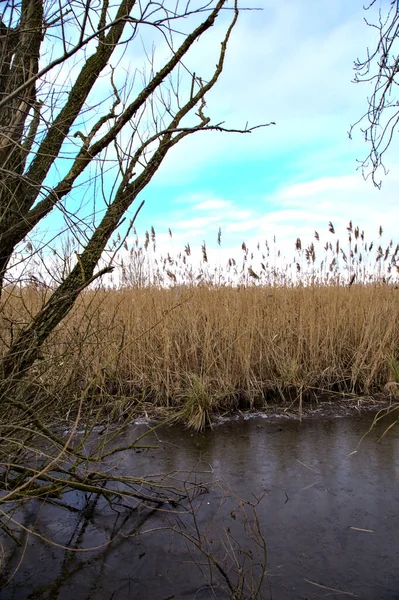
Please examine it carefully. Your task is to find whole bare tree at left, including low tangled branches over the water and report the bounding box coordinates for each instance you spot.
[0,5,276,585]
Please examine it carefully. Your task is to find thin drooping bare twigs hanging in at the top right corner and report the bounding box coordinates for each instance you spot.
[349,0,399,188]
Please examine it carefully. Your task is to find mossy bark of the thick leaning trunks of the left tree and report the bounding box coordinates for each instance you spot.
[0,0,255,381]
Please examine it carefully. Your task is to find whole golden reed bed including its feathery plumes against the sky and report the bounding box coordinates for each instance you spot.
[1,224,399,427]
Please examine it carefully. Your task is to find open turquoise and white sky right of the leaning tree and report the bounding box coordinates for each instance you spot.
[120,0,399,268]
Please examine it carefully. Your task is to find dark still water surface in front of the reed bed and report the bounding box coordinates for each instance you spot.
[0,415,399,600]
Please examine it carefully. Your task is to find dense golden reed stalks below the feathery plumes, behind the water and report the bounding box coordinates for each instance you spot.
[3,285,399,424]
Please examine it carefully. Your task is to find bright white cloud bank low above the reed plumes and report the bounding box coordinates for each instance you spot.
[149,166,399,258]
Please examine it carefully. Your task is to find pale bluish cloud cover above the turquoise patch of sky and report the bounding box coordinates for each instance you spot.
[148,0,375,185]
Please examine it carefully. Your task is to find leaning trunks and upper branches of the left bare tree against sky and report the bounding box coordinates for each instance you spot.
[0,0,272,379]
